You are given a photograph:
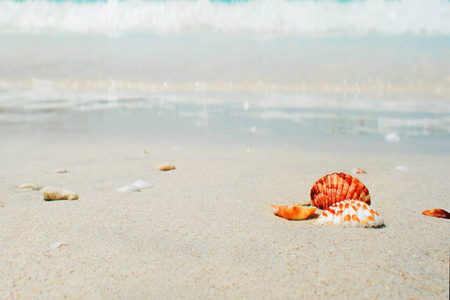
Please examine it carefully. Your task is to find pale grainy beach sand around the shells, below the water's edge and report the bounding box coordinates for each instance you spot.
[0,137,450,299]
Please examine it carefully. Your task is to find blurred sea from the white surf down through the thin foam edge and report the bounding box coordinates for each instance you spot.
[0,0,450,95]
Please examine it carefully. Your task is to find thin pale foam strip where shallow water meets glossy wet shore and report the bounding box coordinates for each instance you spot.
[0,77,450,100]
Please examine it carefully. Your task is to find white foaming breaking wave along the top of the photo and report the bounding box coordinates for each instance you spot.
[0,0,450,36]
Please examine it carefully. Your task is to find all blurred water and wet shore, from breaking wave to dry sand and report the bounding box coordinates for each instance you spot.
[0,0,450,152]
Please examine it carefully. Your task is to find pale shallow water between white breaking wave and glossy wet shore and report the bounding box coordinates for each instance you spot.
[0,34,450,97]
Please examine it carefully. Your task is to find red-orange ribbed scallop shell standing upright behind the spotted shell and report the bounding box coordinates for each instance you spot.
[311,173,370,209]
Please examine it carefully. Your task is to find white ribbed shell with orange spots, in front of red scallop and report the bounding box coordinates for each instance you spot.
[317,200,384,227]
